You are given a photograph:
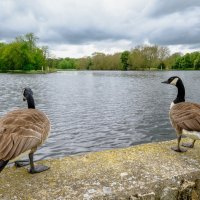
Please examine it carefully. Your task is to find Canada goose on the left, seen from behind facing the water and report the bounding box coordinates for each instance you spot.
[0,88,50,174]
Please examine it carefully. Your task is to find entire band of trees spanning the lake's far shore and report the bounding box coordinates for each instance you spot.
[0,33,200,74]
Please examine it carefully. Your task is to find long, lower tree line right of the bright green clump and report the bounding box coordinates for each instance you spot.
[48,45,200,70]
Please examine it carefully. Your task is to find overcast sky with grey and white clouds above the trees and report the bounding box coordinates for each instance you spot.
[0,0,200,57]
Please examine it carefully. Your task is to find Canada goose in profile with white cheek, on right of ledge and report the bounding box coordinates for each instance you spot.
[162,76,200,152]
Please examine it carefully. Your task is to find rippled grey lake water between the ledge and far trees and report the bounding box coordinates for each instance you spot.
[0,71,200,160]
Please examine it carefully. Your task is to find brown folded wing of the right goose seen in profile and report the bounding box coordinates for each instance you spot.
[170,102,200,132]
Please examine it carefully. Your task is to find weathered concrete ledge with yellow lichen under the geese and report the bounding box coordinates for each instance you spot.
[0,138,200,200]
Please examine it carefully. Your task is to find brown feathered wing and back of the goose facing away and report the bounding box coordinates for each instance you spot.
[0,109,50,160]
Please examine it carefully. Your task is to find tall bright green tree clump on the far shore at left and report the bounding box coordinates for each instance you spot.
[0,33,47,71]
